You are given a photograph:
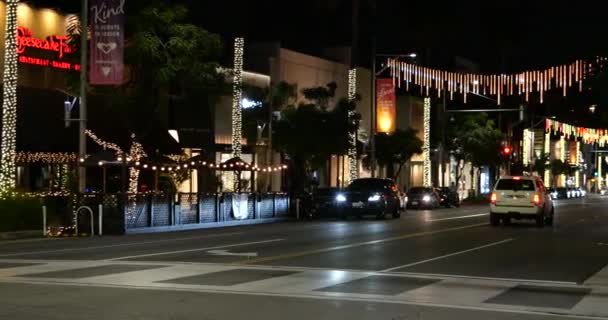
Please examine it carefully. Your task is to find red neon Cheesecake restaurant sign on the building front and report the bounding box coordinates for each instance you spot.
[17,27,80,71]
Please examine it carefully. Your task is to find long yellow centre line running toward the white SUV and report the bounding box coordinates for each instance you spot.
[234,223,488,264]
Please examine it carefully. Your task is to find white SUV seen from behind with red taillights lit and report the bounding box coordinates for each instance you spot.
[490,176,554,227]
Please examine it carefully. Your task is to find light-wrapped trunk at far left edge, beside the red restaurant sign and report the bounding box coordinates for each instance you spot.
[0,0,19,196]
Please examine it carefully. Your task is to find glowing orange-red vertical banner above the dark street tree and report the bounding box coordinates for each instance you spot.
[376,79,397,133]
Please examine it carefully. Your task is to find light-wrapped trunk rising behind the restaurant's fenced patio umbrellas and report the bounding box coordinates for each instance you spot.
[232,38,245,191]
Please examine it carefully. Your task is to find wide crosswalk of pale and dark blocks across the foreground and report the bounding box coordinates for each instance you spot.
[0,259,608,319]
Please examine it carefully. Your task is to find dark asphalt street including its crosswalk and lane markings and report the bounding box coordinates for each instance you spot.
[0,198,608,319]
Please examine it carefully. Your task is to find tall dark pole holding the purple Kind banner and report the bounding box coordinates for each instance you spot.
[78,0,89,192]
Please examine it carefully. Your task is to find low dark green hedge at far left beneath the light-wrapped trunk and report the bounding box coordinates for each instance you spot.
[0,198,42,232]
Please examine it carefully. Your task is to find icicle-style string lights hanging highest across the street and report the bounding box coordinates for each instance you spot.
[387,58,602,105]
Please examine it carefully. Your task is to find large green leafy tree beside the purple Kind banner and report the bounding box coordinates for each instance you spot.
[68,1,227,145]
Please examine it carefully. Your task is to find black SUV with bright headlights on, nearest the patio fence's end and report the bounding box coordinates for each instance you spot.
[336,178,401,219]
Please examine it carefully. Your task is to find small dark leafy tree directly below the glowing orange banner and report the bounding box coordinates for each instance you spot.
[376,128,422,180]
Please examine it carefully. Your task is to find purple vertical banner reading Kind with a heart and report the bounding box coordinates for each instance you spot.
[89,0,125,85]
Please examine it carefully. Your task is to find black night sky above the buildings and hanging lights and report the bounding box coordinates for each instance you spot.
[33,0,608,72]
